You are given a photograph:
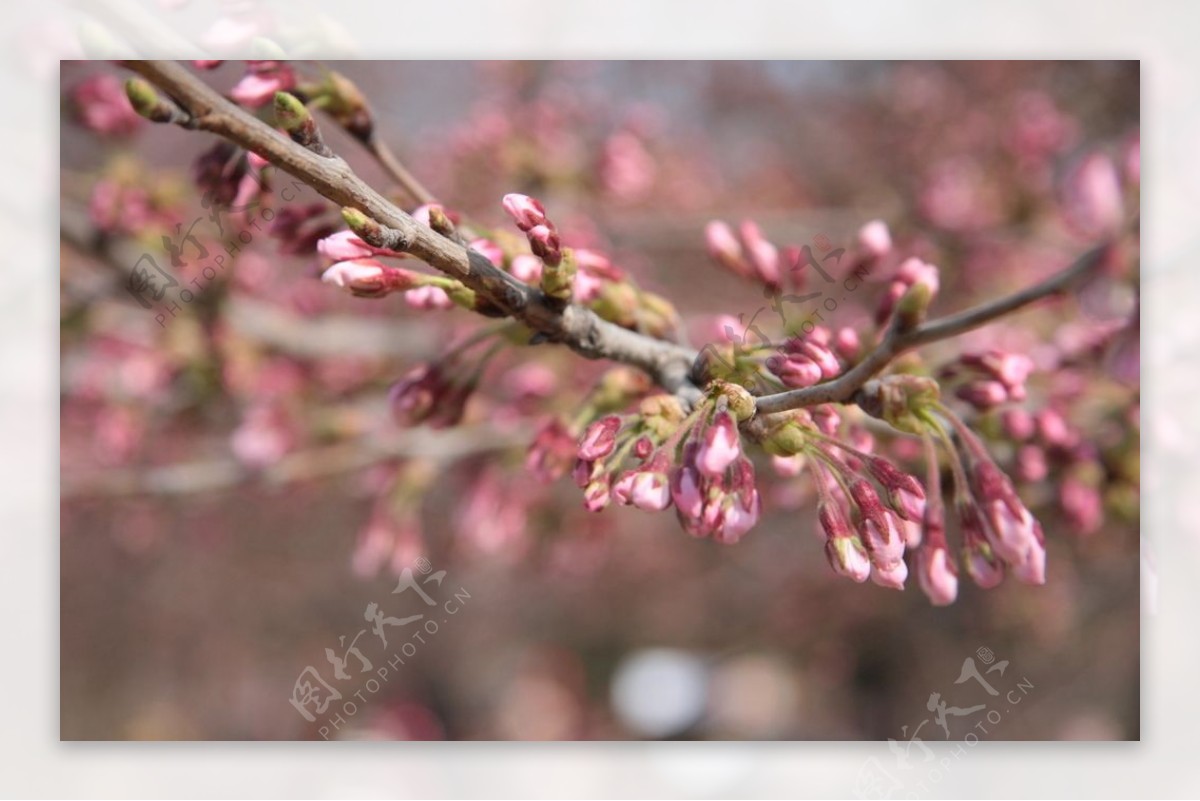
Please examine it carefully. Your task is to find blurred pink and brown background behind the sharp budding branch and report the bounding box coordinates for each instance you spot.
[61,62,1139,753]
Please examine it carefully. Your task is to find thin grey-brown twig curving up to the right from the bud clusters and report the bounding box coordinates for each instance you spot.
[755,245,1108,415]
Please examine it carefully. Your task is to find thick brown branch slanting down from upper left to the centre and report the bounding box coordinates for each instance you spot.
[125,61,700,402]
